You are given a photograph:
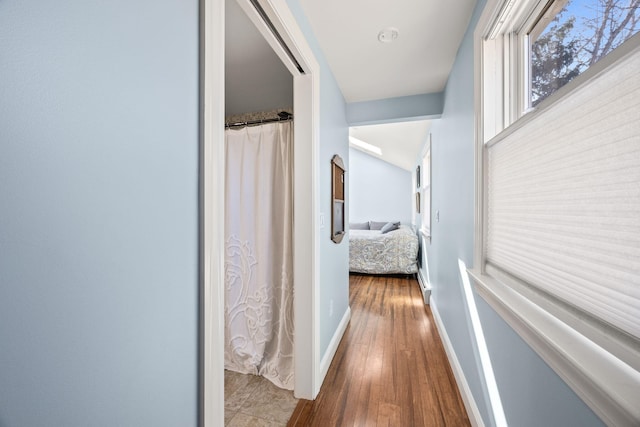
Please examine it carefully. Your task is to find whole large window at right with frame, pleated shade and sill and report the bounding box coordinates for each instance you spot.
[470,0,640,425]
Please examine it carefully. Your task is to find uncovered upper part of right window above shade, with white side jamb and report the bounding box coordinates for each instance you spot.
[478,0,640,142]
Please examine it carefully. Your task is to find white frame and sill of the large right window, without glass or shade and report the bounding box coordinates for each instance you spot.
[467,0,640,425]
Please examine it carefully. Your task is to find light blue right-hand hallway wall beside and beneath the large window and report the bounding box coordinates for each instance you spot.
[416,0,602,427]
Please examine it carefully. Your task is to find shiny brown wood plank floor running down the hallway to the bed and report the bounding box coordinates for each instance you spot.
[287,275,470,427]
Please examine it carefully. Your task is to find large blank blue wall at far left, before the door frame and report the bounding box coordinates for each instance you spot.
[0,0,199,427]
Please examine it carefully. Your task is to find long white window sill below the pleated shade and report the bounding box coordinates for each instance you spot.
[468,270,640,426]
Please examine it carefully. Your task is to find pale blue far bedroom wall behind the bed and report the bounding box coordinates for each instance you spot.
[347,148,414,224]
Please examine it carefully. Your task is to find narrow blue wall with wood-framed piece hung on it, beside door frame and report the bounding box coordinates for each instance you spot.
[287,0,349,358]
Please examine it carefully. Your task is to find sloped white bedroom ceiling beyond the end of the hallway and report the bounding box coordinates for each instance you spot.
[349,120,431,171]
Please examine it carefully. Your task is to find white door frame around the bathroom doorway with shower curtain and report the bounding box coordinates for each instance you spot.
[199,0,321,427]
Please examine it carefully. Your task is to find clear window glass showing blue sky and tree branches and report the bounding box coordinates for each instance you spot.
[530,0,640,106]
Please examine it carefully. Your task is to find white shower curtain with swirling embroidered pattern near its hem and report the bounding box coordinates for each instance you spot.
[224,122,293,390]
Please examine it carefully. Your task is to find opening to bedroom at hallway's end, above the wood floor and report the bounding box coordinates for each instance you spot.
[349,120,431,275]
